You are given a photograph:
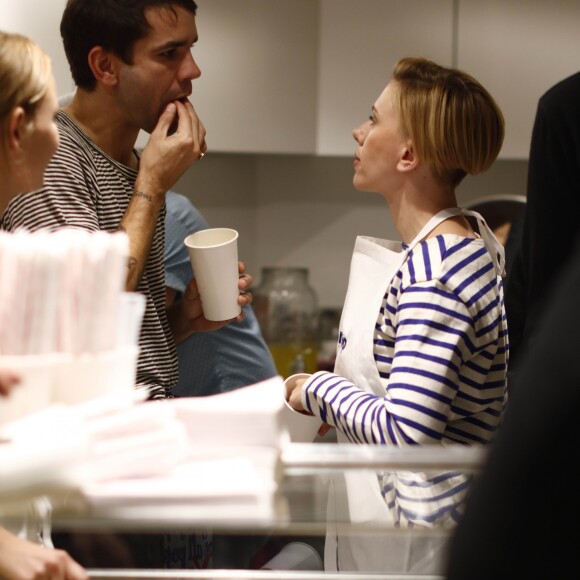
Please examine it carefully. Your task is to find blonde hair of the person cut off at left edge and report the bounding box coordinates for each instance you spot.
[0,31,52,141]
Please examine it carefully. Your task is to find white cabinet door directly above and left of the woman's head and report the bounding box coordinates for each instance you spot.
[316,0,453,155]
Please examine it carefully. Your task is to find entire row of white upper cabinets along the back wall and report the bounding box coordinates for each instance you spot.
[0,0,580,159]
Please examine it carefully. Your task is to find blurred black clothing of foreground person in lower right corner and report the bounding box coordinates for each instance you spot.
[447,236,580,580]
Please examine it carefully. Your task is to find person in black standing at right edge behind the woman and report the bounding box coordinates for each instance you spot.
[506,73,580,390]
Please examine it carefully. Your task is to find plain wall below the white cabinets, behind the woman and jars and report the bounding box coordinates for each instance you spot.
[175,152,527,308]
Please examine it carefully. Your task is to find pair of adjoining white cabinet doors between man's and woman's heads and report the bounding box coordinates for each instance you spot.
[192,0,453,155]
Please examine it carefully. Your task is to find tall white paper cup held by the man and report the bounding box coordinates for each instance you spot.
[185,228,242,320]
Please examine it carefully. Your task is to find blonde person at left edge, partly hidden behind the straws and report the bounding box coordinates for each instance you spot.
[0,31,88,580]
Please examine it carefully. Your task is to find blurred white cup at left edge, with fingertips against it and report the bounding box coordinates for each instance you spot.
[0,355,57,425]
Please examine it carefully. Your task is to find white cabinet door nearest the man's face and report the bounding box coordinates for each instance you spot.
[191,0,318,153]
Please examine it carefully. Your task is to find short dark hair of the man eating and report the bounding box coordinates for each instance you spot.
[60,0,197,91]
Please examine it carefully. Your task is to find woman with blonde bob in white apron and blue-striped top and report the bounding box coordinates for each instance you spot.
[286,58,508,573]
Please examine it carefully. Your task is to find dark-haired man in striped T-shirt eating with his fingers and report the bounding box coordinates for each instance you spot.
[3,0,251,398]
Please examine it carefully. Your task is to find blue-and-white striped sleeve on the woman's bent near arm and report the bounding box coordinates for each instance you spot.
[303,286,474,445]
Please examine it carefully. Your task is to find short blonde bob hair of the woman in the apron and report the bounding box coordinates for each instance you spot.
[393,58,504,185]
